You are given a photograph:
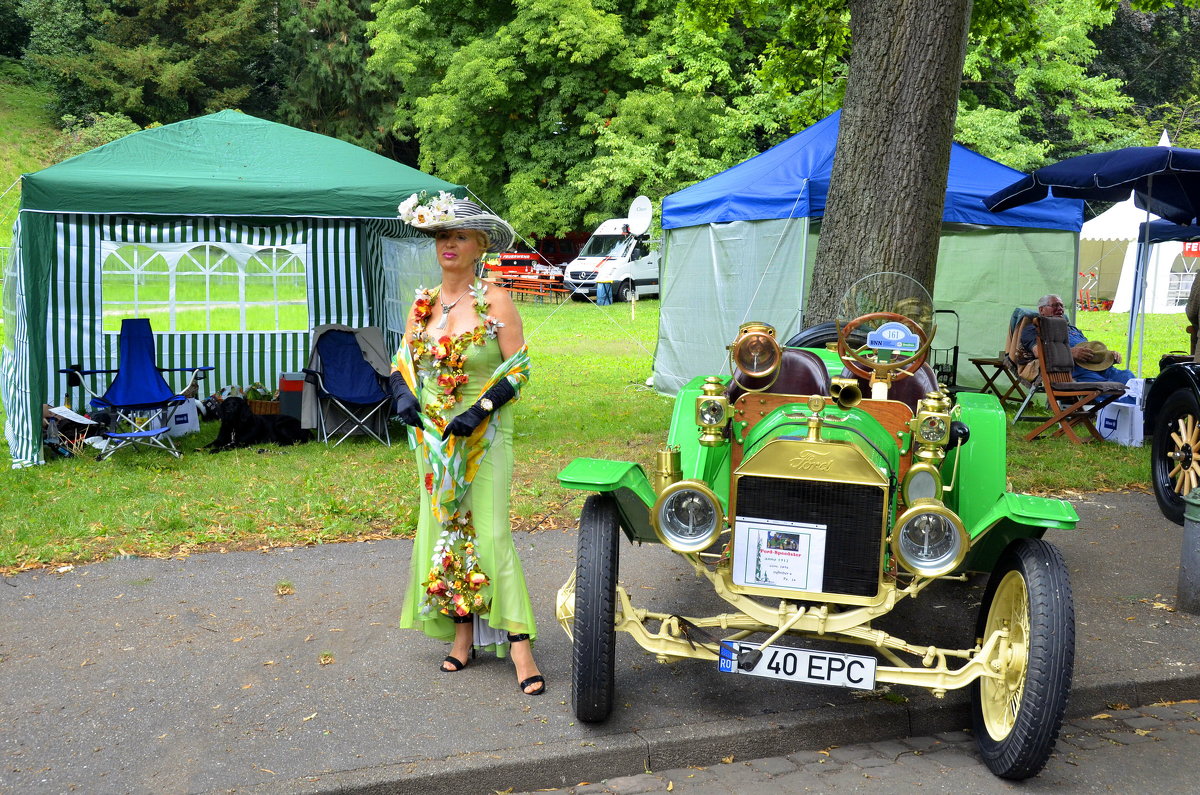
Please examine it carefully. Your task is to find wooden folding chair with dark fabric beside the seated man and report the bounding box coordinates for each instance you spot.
[1025,317,1124,444]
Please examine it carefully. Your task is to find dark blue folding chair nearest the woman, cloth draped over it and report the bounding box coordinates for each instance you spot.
[304,329,391,447]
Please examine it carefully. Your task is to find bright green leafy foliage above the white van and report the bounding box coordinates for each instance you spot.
[370,0,786,237]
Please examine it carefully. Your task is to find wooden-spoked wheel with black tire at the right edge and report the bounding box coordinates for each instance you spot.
[1150,387,1200,525]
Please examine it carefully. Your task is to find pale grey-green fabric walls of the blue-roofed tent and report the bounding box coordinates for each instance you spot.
[654,219,1079,395]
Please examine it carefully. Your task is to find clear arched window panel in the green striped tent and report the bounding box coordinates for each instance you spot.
[101,240,311,334]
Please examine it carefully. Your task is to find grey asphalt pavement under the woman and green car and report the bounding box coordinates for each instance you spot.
[0,494,1200,794]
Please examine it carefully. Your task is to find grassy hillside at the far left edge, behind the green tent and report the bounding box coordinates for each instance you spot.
[0,65,58,250]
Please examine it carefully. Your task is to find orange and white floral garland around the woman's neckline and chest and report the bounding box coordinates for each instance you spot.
[412,280,504,431]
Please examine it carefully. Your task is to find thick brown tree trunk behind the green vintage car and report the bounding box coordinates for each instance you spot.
[804,0,972,325]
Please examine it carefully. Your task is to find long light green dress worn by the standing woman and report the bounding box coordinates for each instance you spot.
[400,321,536,656]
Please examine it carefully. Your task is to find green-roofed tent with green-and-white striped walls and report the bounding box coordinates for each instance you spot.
[0,110,463,467]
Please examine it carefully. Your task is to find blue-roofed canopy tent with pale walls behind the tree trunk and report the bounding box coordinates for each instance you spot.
[654,112,1084,394]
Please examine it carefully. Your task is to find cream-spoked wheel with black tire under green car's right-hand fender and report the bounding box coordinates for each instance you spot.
[971,538,1075,781]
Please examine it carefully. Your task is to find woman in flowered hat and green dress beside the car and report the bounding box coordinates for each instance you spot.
[391,193,546,695]
